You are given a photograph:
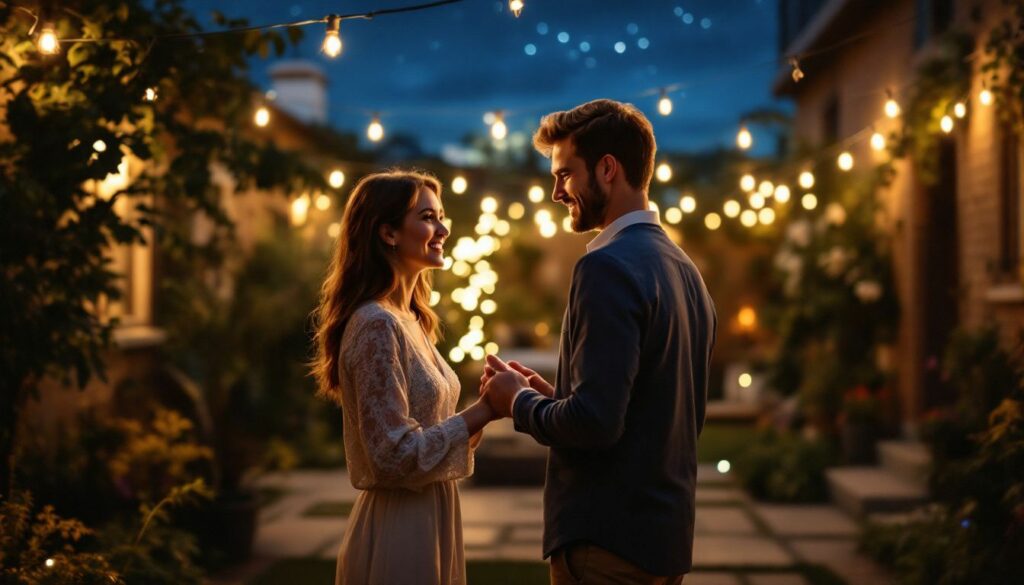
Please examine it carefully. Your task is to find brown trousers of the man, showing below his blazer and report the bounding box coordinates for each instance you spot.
[551,543,683,585]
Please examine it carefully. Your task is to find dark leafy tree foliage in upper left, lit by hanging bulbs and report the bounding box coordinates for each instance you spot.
[0,0,323,489]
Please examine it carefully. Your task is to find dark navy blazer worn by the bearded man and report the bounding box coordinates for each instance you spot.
[513,223,717,575]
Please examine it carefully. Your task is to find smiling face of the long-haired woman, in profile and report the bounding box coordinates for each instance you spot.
[394,186,449,271]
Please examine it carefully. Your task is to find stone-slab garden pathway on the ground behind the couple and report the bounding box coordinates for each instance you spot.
[216,466,889,585]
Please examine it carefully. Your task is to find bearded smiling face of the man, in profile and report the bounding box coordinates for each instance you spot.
[551,138,608,234]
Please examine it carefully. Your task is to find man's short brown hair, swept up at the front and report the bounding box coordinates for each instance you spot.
[534,99,657,191]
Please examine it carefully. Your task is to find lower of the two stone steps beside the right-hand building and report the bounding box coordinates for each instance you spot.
[825,467,928,517]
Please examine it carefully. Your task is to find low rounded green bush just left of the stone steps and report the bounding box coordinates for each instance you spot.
[733,431,836,502]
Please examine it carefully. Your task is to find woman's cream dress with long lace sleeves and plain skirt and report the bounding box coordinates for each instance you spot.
[336,302,473,585]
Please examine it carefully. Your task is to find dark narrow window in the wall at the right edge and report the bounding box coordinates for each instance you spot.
[999,128,1024,280]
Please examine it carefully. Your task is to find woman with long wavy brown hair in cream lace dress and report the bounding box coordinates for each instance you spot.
[313,172,494,585]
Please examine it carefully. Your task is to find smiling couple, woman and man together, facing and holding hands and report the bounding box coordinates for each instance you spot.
[313,99,717,585]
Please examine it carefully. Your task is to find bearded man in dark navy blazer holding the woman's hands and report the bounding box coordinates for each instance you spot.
[481,99,717,585]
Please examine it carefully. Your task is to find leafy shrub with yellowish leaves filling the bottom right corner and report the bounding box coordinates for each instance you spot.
[864,329,1024,585]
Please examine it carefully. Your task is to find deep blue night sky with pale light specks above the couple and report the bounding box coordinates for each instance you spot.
[188,0,784,153]
